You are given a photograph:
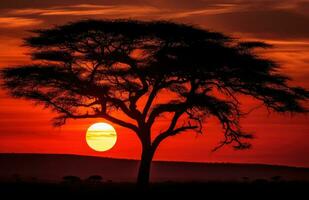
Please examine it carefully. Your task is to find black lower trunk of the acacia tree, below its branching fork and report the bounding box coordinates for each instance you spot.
[137,147,154,190]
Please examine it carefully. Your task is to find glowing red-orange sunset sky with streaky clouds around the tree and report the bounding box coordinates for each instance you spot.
[0,0,309,167]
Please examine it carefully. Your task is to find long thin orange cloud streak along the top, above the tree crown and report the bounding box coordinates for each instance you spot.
[8,4,242,19]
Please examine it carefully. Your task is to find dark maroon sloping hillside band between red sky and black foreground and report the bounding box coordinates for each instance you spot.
[0,154,309,183]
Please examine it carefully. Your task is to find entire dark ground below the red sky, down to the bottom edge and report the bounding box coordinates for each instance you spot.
[0,154,309,200]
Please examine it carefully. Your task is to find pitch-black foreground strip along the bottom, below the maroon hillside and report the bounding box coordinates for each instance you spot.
[0,180,309,199]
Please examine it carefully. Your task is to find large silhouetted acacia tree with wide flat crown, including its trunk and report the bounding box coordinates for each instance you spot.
[2,20,309,186]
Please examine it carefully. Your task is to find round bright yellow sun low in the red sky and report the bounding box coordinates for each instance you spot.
[86,123,117,152]
